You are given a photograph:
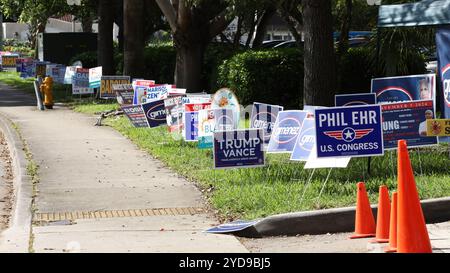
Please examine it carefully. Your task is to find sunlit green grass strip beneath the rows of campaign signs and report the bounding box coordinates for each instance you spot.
[74,103,450,220]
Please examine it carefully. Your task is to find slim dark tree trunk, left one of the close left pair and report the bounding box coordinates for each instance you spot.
[97,0,115,75]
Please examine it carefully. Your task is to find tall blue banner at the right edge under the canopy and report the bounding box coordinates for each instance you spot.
[436,26,450,142]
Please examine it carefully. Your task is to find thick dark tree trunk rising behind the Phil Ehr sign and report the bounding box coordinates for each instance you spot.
[302,0,336,106]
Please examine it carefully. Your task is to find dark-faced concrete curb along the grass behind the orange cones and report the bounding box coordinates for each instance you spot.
[235,197,450,238]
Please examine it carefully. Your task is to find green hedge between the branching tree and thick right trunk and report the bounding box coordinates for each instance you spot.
[218,49,303,109]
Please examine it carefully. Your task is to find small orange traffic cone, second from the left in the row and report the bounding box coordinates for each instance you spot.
[371,186,391,243]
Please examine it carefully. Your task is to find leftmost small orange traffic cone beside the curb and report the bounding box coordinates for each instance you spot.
[350,182,375,239]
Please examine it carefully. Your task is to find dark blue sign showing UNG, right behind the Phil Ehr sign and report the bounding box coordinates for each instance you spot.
[382,100,438,149]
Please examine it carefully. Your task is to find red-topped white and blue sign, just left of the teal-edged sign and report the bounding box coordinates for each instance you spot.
[183,102,211,142]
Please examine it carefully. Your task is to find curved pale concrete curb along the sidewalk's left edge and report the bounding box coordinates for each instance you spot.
[0,114,33,253]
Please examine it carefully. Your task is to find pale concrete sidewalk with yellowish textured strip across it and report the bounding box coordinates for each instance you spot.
[0,84,248,253]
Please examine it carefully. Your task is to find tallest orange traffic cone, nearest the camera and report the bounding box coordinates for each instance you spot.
[397,140,432,253]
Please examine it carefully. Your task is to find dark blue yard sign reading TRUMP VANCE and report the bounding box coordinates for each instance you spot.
[213,129,265,169]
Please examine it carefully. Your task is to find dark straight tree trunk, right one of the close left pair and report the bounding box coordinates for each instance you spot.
[123,0,144,78]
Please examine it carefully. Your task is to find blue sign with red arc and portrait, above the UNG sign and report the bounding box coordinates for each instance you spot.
[372,74,436,104]
